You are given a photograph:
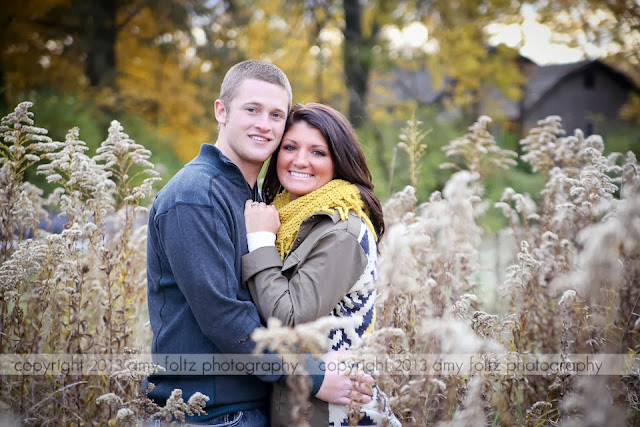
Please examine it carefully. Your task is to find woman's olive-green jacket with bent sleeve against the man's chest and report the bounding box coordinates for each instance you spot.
[242,212,367,426]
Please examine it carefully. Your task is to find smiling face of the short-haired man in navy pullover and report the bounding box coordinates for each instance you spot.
[215,79,289,173]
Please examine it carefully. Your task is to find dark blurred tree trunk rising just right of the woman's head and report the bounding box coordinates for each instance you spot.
[342,0,371,127]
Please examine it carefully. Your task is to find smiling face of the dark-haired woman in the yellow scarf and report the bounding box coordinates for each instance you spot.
[276,122,333,200]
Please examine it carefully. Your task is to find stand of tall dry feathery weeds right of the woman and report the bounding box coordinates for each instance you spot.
[365,117,640,426]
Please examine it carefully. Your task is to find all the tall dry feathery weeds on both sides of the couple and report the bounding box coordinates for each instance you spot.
[0,103,640,426]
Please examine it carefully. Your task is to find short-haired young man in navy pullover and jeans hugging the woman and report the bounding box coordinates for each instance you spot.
[147,61,369,426]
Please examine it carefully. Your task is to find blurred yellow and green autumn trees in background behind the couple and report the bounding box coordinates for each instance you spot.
[0,0,640,229]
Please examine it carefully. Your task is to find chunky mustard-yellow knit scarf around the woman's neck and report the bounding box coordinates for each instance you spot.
[273,179,377,259]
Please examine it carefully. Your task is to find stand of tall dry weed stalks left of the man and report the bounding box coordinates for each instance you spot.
[0,102,171,426]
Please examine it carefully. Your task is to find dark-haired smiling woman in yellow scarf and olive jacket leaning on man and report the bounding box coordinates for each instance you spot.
[242,103,399,427]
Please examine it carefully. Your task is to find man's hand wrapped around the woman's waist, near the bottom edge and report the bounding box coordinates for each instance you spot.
[316,350,374,405]
